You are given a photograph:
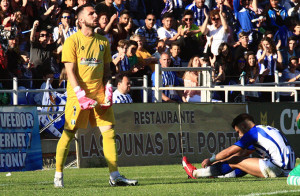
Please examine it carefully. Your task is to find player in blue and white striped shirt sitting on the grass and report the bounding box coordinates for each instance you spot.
[182,113,295,179]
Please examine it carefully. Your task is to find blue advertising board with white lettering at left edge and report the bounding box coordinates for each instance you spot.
[0,106,43,172]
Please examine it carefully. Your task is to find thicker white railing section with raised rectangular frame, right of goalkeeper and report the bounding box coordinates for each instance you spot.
[154,64,300,103]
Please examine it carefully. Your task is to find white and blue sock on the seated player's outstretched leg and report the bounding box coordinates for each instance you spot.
[193,162,233,178]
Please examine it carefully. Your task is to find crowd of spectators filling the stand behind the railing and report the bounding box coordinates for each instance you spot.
[0,0,300,104]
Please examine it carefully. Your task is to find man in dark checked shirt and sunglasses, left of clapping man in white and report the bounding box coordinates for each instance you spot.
[135,14,158,54]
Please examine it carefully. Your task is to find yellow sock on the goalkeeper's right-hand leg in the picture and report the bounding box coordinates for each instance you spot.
[102,129,118,173]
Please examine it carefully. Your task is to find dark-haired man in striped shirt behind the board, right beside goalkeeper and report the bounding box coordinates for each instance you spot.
[113,73,133,103]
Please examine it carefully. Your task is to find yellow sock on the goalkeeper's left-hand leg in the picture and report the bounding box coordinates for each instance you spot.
[56,131,75,172]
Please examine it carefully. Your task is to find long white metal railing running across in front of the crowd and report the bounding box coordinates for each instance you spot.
[0,69,300,105]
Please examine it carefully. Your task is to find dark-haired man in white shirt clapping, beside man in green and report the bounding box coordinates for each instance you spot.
[157,13,180,45]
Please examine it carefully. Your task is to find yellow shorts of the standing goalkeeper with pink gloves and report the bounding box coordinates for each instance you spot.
[64,97,115,130]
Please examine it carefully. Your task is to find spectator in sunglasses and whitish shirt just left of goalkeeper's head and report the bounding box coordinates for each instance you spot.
[53,10,77,41]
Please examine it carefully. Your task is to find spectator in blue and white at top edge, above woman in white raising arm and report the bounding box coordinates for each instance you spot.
[185,0,209,26]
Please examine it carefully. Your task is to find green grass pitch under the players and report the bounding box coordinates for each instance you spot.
[0,160,300,196]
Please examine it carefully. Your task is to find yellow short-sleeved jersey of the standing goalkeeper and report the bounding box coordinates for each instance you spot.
[62,30,111,97]
